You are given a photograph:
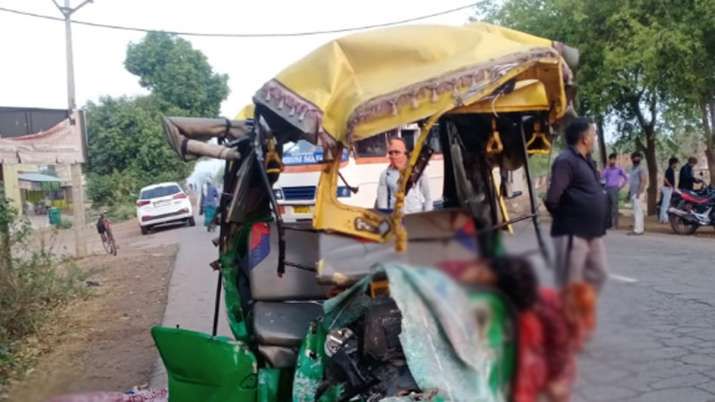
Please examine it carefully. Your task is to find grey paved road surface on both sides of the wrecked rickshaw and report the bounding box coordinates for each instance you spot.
[147,217,715,402]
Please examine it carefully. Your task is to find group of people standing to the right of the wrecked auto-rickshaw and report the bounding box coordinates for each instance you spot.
[545,117,702,291]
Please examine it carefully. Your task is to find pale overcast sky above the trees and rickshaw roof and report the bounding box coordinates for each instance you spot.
[0,0,473,117]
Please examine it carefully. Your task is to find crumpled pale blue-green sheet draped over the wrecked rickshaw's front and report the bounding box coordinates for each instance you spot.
[323,264,506,402]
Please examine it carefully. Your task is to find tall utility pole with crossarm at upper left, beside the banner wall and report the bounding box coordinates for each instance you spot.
[52,0,93,258]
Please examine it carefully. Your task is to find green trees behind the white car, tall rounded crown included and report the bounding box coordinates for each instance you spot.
[86,33,229,205]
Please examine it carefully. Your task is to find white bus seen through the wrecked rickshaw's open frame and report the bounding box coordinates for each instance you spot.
[273,125,444,222]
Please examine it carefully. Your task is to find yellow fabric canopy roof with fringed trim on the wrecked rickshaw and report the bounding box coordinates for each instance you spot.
[254,23,568,143]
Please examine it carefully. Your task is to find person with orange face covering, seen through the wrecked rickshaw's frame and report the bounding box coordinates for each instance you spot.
[376,138,434,214]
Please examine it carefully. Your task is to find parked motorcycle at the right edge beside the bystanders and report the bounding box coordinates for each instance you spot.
[668,186,715,235]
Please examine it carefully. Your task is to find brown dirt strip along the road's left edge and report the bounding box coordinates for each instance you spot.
[1,222,177,402]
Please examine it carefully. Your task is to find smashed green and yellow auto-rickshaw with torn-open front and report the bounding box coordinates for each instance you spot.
[152,23,578,402]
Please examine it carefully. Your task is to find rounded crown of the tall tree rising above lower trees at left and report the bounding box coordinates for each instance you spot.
[124,32,229,117]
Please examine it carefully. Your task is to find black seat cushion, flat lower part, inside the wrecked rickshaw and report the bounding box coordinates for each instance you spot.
[253,302,323,346]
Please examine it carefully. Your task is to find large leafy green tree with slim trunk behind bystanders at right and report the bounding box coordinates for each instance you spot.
[487,0,712,213]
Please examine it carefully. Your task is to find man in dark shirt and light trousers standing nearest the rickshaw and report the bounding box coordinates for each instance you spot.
[545,117,607,290]
